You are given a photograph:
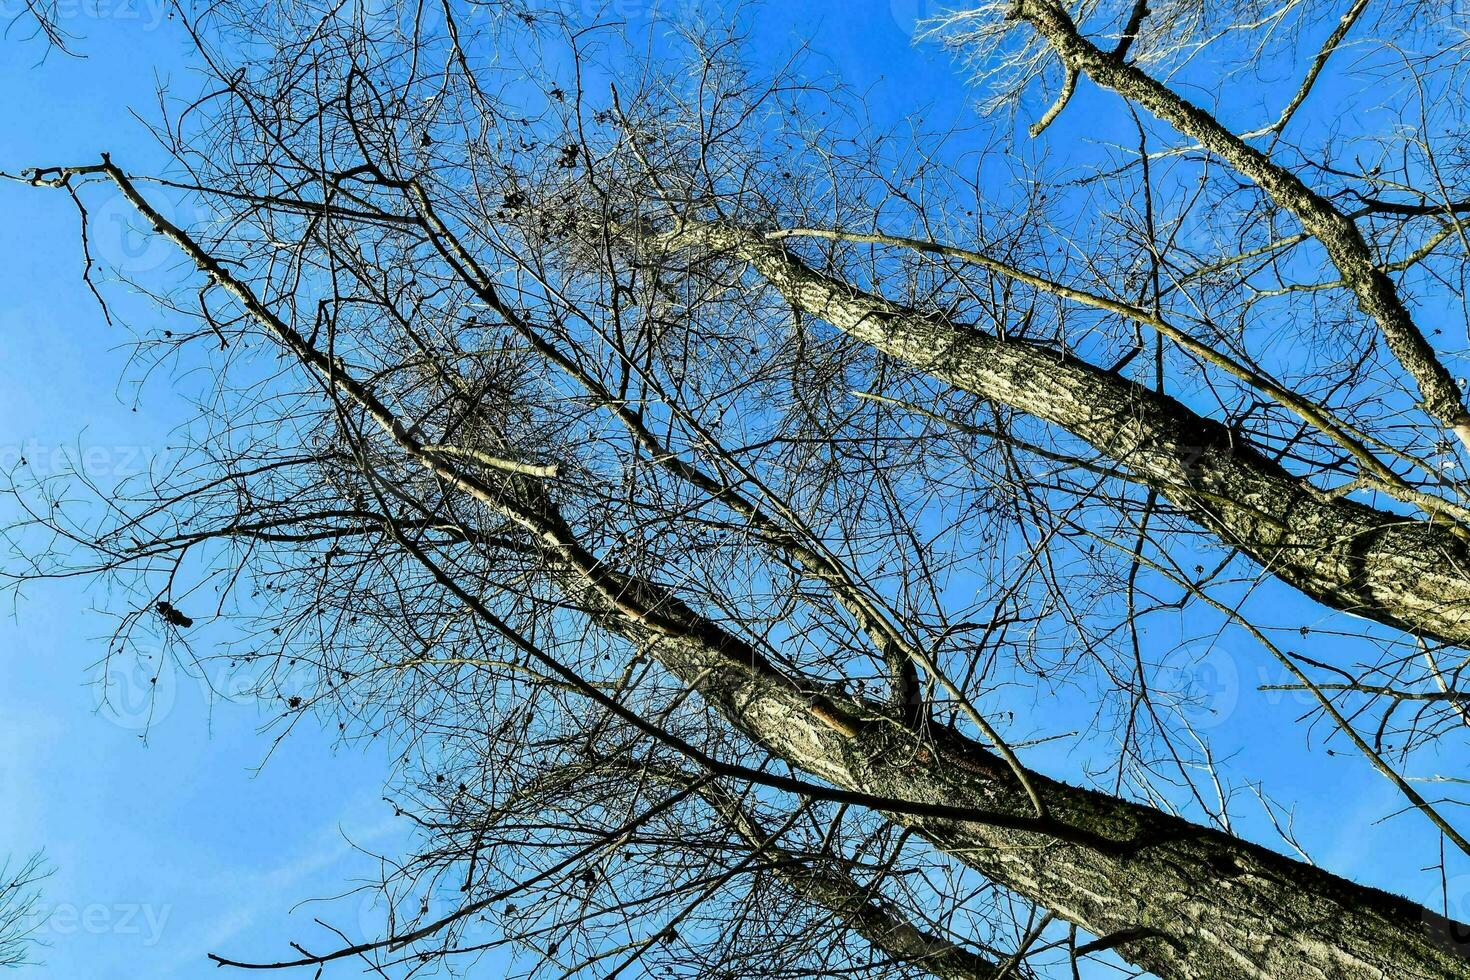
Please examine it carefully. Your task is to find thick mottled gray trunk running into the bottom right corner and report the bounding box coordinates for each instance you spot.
[637,627,1470,980]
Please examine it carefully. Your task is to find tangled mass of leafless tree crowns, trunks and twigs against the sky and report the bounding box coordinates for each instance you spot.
[10,0,1470,977]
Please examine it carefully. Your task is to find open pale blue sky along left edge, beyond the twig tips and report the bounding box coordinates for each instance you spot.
[0,11,414,980]
